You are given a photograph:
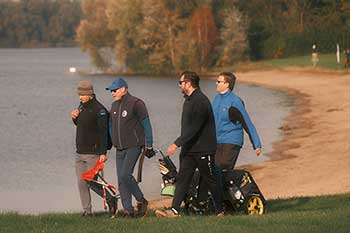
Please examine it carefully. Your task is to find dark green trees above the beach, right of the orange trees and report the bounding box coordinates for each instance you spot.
[239,0,350,60]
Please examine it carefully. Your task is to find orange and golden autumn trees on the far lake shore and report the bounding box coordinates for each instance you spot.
[77,0,248,73]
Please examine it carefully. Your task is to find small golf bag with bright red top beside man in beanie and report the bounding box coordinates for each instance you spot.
[80,160,120,218]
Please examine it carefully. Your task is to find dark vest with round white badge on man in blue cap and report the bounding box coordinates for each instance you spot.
[110,93,148,150]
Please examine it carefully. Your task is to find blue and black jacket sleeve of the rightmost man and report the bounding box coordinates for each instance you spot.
[229,103,261,149]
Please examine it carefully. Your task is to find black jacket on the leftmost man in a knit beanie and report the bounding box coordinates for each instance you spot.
[73,98,109,155]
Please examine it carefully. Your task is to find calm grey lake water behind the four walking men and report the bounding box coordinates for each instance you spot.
[0,49,290,214]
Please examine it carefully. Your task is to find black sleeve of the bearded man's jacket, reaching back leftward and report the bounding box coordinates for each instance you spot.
[174,102,210,147]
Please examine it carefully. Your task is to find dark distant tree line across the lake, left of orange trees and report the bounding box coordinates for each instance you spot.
[0,0,82,47]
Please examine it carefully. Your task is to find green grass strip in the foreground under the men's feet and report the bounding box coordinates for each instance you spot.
[0,194,350,233]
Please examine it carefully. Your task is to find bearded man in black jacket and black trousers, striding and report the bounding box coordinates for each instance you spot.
[156,71,223,217]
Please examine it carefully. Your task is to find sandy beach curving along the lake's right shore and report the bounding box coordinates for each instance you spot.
[151,70,350,208]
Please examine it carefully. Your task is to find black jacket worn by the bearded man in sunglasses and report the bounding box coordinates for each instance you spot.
[175,88,216,155]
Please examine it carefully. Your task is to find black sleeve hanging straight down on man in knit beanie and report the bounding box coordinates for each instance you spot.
[97,109,109,155]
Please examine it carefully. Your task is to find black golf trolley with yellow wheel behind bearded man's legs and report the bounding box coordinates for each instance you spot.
[157,150,266,215]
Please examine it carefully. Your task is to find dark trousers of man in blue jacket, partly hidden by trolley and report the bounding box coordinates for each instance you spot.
[197,144,241,202]
